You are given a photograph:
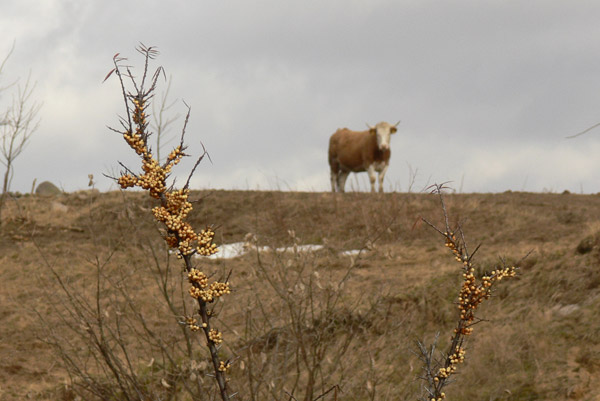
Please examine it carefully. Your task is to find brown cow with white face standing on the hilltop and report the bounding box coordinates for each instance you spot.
[329,121,400,192]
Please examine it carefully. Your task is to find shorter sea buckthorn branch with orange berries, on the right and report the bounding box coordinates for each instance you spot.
[417,184,527,401]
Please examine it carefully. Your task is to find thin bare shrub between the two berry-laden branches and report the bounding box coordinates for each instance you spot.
[234,227,403,401]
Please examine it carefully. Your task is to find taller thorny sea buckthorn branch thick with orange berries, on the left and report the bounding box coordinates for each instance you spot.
[105,45,231,401]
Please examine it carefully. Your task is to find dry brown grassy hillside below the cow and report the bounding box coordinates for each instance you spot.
[0,191,600,400]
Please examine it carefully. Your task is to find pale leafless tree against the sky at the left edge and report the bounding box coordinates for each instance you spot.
[0,45,41,224]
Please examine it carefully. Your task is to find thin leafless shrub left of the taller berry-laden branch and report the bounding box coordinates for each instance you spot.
[36,192,221,400]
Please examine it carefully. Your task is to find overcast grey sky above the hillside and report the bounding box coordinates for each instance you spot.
[0,0,600,193]
